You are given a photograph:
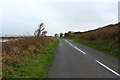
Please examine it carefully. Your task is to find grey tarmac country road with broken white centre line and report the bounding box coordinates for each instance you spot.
[48,39,120,78]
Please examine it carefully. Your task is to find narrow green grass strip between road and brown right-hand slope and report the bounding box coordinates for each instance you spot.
[63,38,120,58]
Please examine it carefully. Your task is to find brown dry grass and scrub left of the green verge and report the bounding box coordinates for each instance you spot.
[2,37,54,77]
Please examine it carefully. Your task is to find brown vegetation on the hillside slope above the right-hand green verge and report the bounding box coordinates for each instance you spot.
[65,23,120,43]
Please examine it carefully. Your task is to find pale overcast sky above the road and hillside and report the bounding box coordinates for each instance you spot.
[0,0,119,35]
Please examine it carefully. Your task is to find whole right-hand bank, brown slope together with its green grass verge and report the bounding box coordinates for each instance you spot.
[64,23,120,58]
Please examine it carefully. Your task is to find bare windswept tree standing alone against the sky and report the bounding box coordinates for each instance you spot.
[34,23,47,36]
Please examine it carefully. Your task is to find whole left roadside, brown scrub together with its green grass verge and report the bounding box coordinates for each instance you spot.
[2,37,57,78]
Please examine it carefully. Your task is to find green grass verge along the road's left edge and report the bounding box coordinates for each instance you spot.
[6,40,58,78]
